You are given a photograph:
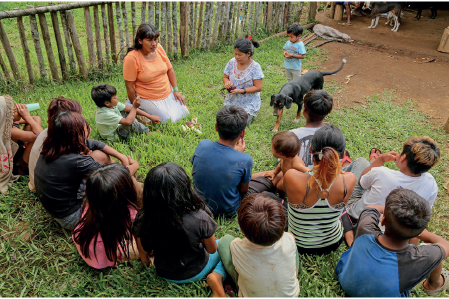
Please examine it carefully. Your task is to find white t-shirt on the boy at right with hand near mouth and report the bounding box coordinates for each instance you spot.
[348,166,438,219]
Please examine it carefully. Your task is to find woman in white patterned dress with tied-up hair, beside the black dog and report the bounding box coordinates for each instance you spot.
[223,36,264,124]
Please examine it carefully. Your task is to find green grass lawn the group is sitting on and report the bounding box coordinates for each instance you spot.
[0,34,449,297]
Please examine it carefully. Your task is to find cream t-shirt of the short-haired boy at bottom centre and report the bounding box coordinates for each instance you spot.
[230,233,299,298]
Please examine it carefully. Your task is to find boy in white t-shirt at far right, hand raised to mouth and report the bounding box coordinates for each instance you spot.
[347,136,440,219]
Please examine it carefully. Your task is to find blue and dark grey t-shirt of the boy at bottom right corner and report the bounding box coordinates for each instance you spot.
[335,208,446,298]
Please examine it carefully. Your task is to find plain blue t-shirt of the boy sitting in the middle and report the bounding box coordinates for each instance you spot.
[190,139,253,216]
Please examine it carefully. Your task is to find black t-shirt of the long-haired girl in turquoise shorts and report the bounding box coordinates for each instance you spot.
[133,210,217,280]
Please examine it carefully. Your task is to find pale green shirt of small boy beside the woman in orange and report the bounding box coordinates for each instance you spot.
[95,102,126,141]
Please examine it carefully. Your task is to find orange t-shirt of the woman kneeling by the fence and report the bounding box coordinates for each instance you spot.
[123,44,173,101]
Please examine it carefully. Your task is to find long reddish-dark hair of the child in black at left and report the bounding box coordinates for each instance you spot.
[41,111,90,163]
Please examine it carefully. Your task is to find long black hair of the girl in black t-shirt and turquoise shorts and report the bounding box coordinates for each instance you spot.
[140,162,208,259]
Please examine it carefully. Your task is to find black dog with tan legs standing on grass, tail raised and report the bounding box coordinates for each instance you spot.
[270,59,346,132]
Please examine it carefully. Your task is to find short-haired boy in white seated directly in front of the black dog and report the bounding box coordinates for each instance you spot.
[290,90,333,169]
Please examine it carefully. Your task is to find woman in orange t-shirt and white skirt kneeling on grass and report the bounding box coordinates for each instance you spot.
[123,24,189,122]
